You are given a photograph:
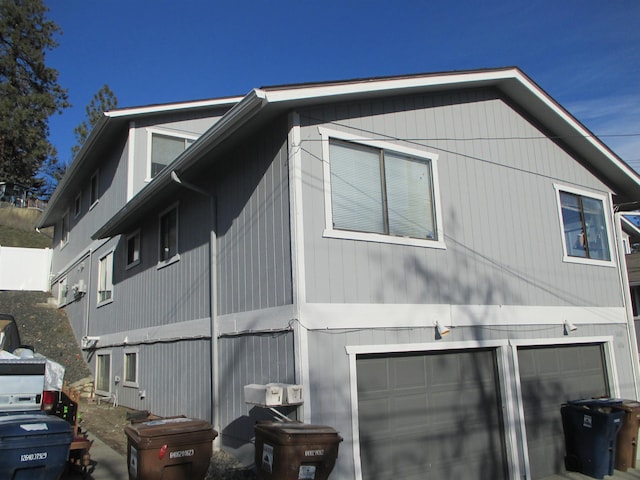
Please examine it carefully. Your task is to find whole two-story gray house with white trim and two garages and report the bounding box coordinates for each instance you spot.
[39,68,640,480]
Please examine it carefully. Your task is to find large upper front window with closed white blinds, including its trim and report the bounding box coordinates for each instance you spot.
[321,129,444,248]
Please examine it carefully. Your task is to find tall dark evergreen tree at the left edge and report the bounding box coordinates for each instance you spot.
[0,0,69,189]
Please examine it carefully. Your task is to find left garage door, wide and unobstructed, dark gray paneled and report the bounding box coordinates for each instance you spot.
[357,350,506,480]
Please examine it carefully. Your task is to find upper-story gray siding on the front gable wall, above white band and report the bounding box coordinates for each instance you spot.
[301,87,622,306]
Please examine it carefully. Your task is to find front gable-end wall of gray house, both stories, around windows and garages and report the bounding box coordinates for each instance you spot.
[292,90,637,478]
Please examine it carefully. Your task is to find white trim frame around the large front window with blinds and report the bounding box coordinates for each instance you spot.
[318,127,446,249]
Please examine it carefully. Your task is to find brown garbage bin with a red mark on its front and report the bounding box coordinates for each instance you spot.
[124,417,218,480]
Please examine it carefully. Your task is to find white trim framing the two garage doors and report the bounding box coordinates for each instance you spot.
[345,336,620,480]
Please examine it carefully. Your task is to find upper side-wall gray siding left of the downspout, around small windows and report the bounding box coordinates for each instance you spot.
[89,192,211,335]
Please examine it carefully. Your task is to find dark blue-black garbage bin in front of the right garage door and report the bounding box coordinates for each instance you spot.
[560,399,625,478]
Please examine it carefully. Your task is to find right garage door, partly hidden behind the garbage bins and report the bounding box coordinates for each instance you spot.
[518,345,609,479]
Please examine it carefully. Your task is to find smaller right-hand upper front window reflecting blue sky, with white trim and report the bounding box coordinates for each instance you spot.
[556,185,612,264]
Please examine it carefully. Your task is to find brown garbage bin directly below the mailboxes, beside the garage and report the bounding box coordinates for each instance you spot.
[254,422,342,480]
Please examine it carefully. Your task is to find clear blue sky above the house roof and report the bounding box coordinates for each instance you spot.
[45,0,640,169]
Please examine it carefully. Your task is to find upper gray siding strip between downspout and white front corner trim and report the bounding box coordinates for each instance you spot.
[216,122,292,315]
